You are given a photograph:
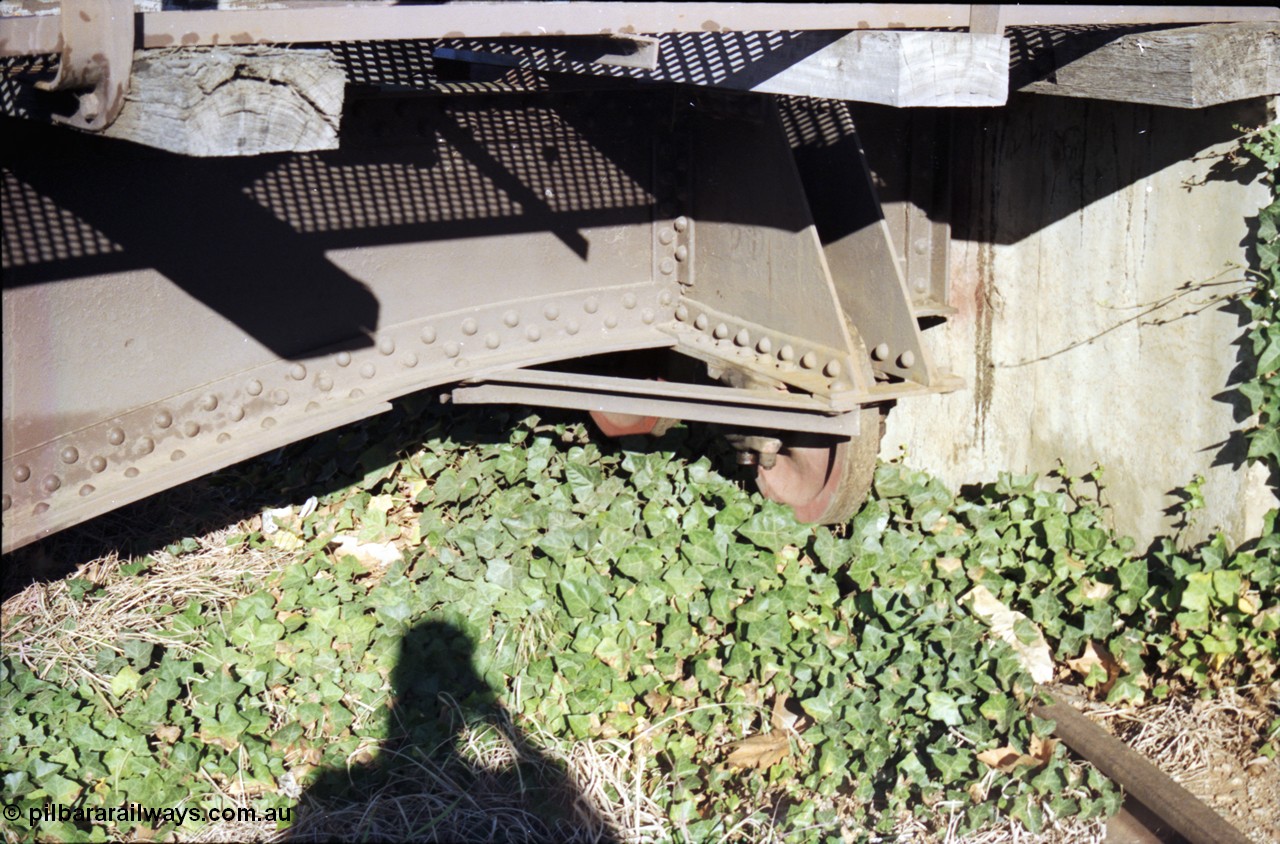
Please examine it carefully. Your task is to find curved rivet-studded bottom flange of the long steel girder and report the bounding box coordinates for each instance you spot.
[3,283,675,552]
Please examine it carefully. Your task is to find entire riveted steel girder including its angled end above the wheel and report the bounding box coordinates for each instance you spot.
[0,81,950,551]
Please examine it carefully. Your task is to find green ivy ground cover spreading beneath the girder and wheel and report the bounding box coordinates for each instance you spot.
[0,402,1280,840]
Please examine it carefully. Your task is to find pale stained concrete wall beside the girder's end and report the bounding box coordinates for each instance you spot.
[882,95,1276,543]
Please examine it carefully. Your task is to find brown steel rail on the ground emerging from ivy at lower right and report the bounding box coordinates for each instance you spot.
[1034,694,1249,844]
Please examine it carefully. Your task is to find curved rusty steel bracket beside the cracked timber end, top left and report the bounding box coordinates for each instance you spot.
[37,0,134,132]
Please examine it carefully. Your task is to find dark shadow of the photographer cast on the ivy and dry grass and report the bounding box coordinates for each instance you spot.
[278,620,617,844]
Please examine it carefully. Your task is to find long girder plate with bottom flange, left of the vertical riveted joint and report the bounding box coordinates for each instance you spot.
[3,93,682,551]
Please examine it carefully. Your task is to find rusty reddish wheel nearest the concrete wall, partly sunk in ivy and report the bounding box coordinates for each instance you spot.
[755,407,883,525]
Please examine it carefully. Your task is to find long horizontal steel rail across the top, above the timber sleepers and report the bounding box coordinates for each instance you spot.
[0,1,1280,56]
